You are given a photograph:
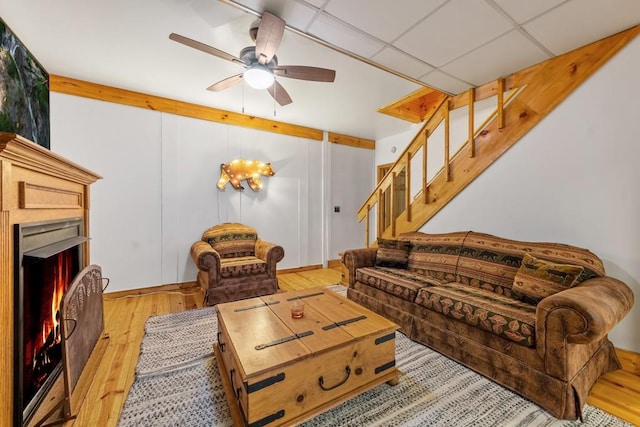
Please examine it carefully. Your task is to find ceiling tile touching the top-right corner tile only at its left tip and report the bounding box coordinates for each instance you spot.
[393,0,512,67]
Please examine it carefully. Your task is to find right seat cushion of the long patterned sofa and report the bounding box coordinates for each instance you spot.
[415,282,536,347]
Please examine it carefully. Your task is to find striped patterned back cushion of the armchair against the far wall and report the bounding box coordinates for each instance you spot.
[202,222,258,258]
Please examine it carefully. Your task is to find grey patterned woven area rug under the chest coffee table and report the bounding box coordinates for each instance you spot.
[118,285,631,427]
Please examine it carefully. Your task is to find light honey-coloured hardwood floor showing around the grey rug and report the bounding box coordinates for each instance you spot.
[55,268,640,427]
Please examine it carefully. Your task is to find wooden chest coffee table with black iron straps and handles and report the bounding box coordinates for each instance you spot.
[214,288,399,426]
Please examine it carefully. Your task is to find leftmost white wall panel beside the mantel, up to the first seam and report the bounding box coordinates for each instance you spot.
[51,98,166,291]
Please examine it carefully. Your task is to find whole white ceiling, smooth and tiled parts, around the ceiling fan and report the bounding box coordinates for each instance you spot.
[0,0,640,139]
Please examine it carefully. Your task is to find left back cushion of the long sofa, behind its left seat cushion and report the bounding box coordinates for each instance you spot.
[398,232,467,282]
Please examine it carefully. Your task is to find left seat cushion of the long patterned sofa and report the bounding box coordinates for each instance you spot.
[356,267,438,302]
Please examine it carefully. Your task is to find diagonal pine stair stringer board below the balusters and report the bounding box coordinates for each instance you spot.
[380,25,640,238]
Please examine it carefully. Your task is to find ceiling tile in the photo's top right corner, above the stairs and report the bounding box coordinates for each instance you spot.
[524,0,640,55]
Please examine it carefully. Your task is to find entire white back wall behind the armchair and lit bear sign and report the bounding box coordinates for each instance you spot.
[51,93,373,291]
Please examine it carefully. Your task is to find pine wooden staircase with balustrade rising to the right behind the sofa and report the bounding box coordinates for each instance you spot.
[358,26,640,247]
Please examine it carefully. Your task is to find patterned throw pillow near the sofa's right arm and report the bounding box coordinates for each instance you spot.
[512,254,584,304]
